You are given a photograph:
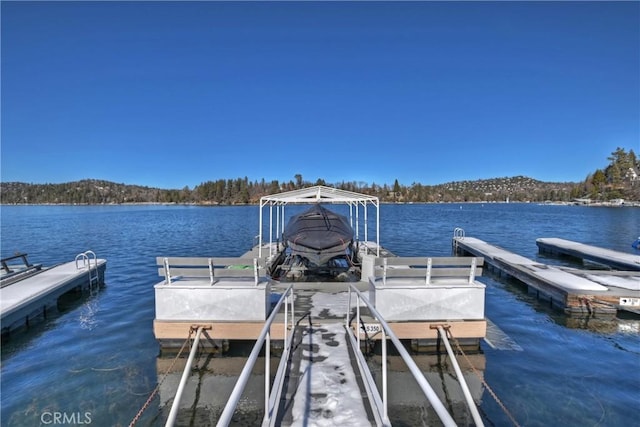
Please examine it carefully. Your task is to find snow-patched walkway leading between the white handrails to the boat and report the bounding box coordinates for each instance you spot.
[276,289,375,426]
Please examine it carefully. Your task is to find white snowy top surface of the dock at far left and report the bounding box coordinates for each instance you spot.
[0,259,106,318]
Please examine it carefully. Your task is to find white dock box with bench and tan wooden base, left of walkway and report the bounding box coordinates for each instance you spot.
[154,257,280,344]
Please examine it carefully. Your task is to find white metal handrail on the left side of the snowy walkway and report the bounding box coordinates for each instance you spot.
[216,285,295,426]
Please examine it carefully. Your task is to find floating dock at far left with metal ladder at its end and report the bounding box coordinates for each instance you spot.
[0,251,107,340]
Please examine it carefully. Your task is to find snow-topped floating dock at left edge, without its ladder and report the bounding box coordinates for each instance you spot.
[0,254,107,336]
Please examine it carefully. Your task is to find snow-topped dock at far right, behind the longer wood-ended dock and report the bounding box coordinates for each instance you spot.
[536,237,640,271]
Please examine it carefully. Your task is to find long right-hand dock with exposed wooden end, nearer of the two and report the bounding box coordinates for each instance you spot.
[453,230,640,317]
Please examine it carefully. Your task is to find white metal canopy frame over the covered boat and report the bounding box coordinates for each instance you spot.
[258,185,380,257]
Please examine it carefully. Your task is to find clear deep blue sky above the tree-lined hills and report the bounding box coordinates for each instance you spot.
[1,1,640,189]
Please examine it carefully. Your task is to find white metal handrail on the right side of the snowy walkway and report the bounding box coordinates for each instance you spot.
[346,285,456,426]
